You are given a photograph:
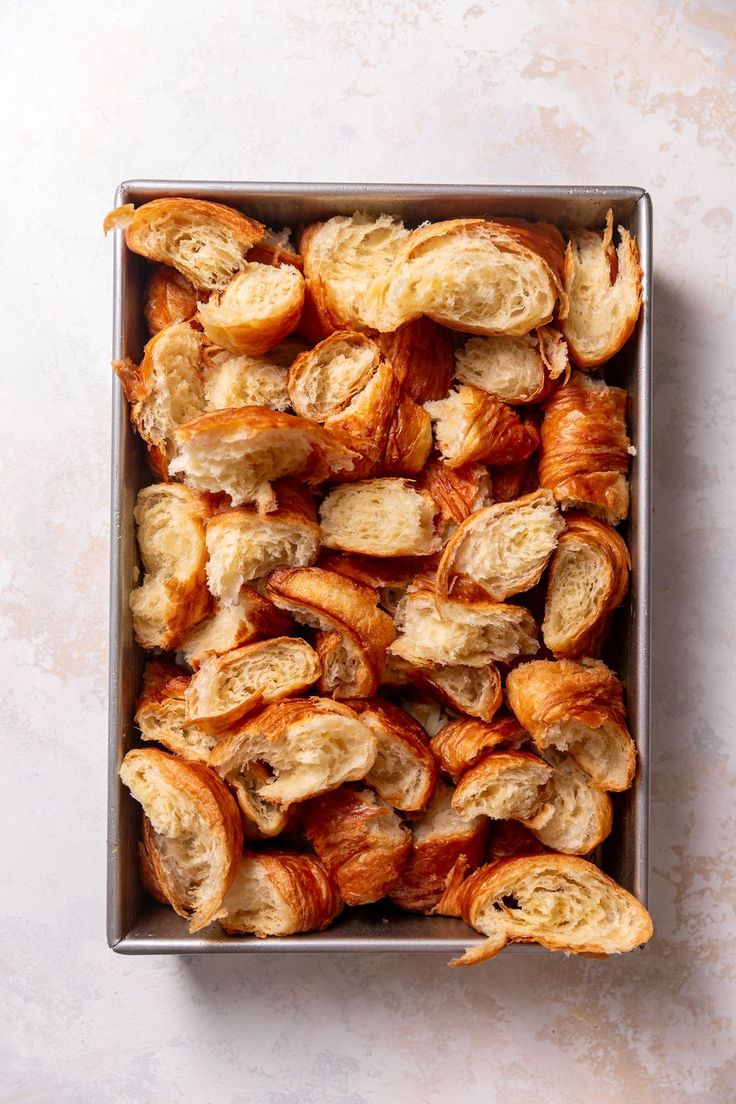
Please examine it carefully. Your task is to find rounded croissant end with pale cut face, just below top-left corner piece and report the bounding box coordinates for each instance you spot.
[196,261,305,357]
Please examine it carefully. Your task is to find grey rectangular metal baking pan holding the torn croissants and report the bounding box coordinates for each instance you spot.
[107,180,652,956]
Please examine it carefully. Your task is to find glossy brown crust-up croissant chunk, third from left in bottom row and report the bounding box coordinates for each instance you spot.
[306,786,412,905]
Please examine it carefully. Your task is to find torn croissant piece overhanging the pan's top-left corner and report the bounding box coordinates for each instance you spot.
[105,198,266,291]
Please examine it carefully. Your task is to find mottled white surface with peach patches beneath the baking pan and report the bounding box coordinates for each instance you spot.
[0,0,736,1104]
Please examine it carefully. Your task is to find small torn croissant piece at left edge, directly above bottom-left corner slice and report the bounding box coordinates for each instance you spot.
[135,659,215,763]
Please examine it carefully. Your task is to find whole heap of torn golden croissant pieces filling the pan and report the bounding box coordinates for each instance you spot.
[106,199,652,964]
